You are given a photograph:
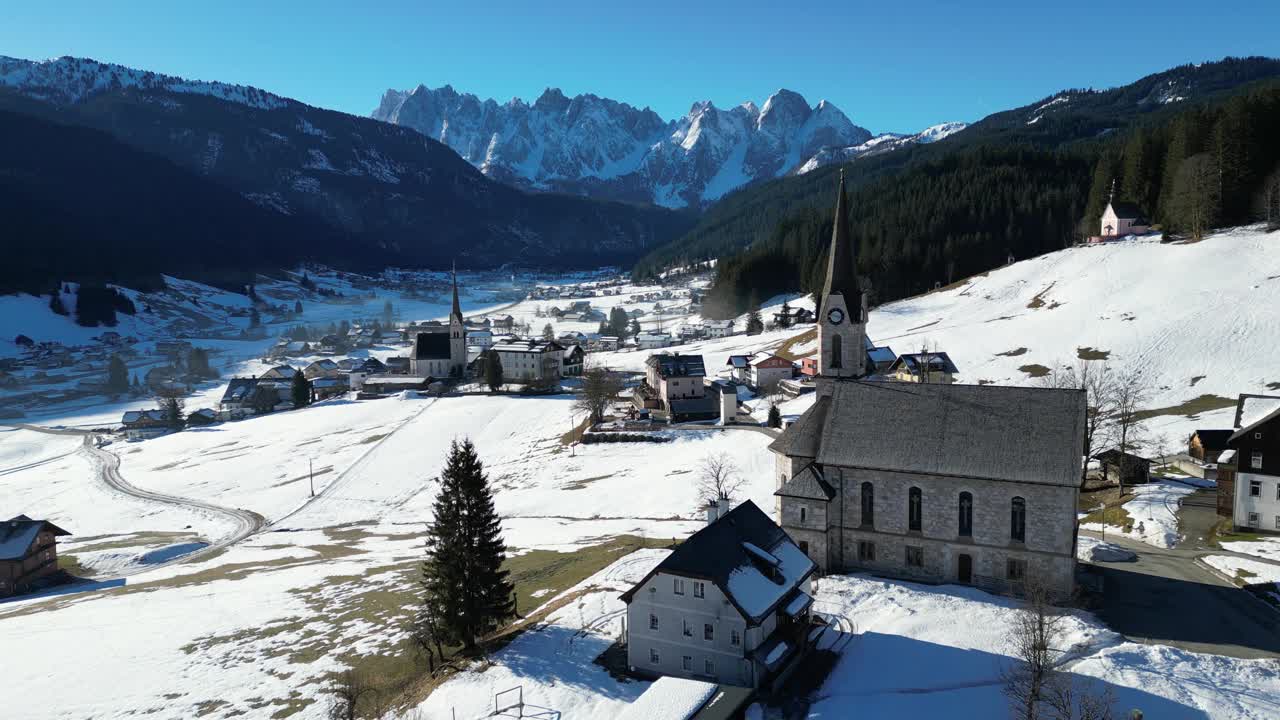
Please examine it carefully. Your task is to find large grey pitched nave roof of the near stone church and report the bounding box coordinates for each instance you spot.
[769,380,1084,486]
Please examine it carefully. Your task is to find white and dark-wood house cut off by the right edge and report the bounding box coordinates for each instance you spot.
[1219,395,1280,533]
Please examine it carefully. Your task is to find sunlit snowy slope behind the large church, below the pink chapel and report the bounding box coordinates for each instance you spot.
[868,228,1280,443]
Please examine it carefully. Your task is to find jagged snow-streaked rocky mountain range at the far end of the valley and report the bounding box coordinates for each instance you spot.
[372,85,964,208]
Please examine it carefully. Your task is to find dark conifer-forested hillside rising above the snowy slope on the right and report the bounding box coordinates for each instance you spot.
[636,59,1280,315]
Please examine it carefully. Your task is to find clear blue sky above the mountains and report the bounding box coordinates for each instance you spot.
[0,0,1280,132]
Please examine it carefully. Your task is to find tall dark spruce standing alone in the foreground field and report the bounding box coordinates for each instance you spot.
[422,439,516,651]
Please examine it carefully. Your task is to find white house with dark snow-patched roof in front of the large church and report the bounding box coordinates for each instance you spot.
[622,501,817,688]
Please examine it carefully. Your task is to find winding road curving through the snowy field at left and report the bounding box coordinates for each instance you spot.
[3,424,266,577]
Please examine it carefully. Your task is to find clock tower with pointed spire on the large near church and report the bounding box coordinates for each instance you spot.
[818,170,867,378]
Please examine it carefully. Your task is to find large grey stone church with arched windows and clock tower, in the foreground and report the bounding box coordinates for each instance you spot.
[769,176,1085,597]
